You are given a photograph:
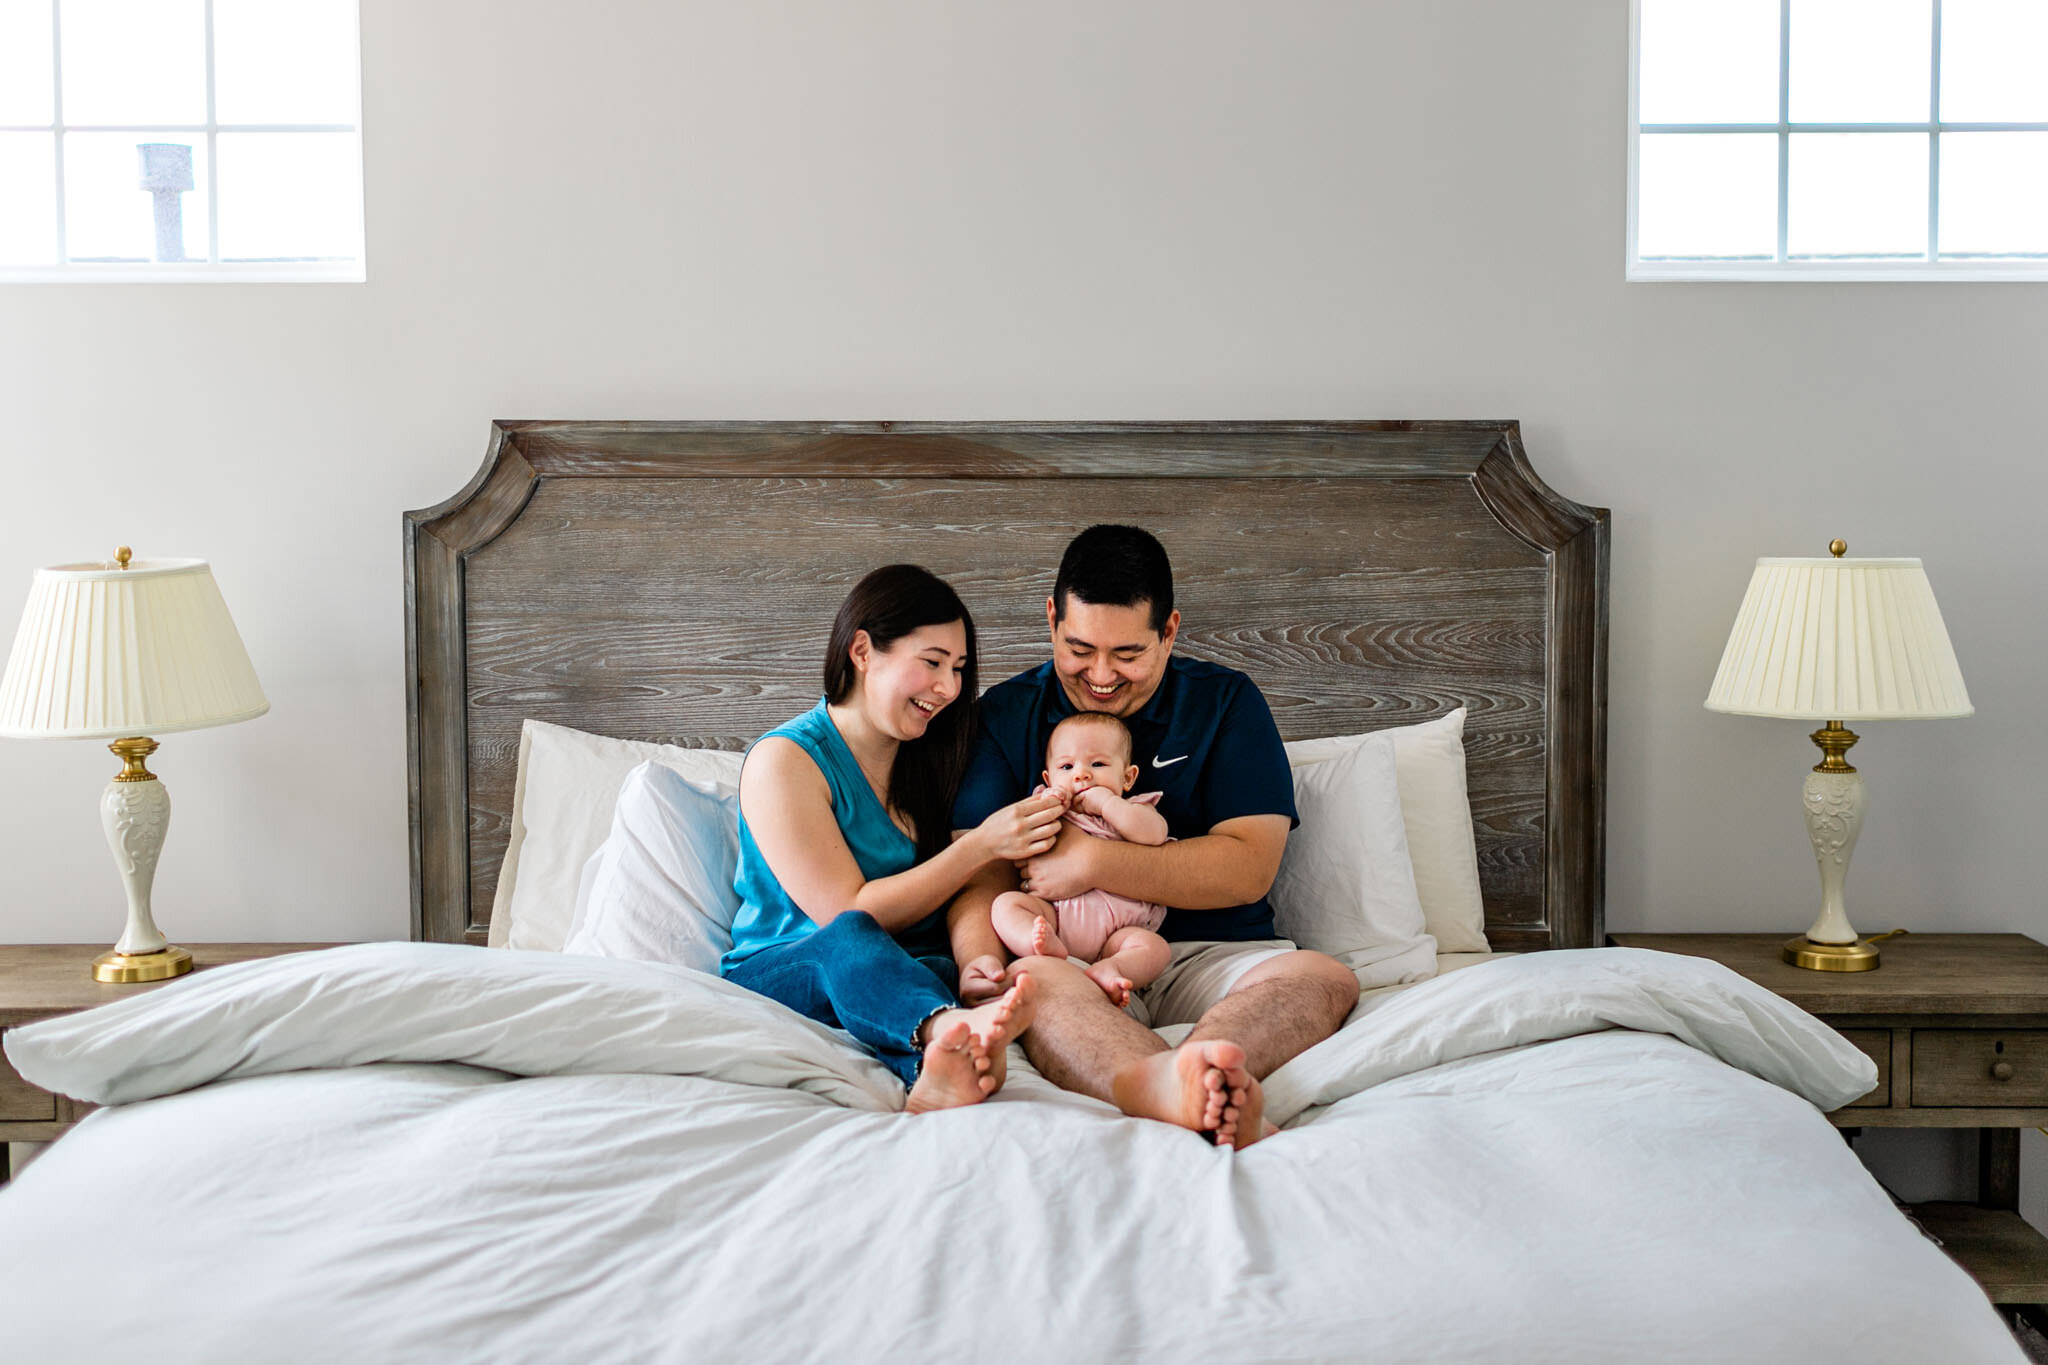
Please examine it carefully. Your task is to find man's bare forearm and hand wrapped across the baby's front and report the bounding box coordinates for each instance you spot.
[1019,814,1290,911]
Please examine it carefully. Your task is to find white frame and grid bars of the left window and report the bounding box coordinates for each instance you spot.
[0,0,369,284]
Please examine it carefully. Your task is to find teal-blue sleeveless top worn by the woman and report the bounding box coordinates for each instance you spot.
[719,700,950,972]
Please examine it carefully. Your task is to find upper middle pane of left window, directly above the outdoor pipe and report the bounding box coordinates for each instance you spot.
[59,0,207,123]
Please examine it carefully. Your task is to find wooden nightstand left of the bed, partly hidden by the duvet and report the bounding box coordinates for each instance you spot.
[0,943,332,1181]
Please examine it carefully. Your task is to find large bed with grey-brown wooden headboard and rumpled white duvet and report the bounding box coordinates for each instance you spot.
[0,422,2019,1361]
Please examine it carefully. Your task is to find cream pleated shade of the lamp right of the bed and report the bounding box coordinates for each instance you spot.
[1706,559,1976,720]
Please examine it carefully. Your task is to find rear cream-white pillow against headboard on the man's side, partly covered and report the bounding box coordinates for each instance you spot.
[1286,706,1487,954]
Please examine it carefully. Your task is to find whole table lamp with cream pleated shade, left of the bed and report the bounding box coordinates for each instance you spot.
[0,546,270,980]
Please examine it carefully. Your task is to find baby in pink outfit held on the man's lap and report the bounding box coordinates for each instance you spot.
[989,710,1174,1007]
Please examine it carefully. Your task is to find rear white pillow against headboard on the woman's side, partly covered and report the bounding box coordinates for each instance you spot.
[489,720,745,952]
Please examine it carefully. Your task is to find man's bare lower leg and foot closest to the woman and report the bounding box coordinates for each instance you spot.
[1016,958,1257,1142]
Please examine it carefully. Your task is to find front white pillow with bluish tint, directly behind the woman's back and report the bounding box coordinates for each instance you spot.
[561,763,739,976]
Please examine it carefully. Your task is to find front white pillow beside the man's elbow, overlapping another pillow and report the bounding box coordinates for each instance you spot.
[1272,735,1436,976]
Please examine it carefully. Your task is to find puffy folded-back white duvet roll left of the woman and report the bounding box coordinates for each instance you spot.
[4,943,903,1109]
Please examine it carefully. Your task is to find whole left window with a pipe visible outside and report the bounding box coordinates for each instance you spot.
[0,0,362,282]
